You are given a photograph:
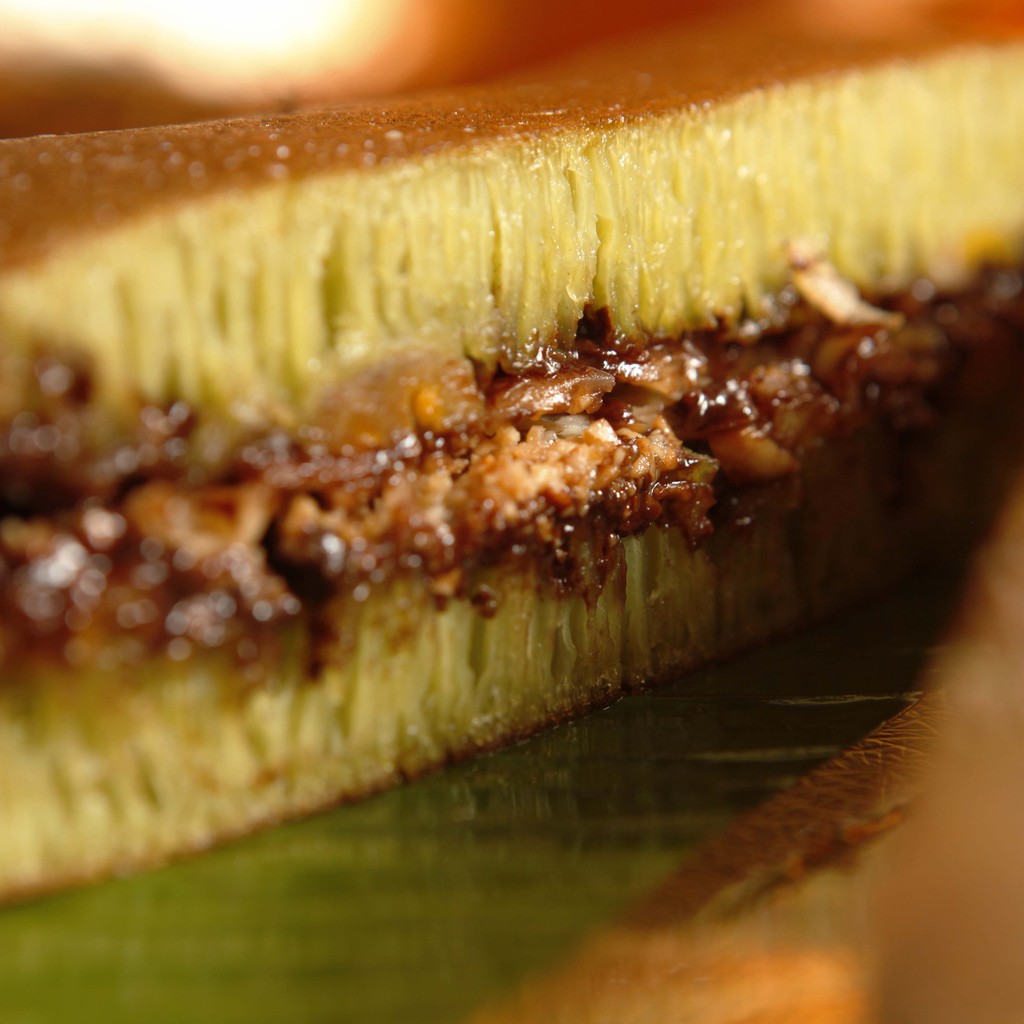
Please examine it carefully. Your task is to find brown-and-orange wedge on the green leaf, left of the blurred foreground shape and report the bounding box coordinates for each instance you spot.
[473,701,942,1024]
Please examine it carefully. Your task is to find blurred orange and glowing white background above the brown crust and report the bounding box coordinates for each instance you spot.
[0,0,1020,137]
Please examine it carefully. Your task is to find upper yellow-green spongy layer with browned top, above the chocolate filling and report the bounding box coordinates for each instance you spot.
[0,46,1024,416]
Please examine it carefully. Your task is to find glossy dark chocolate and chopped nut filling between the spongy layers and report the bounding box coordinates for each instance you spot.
[0,270,1024,671]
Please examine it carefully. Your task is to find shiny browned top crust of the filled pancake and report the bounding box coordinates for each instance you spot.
[0,15,1011,269]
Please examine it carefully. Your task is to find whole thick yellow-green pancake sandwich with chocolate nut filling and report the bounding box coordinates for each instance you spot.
[0,12,1024,897]
